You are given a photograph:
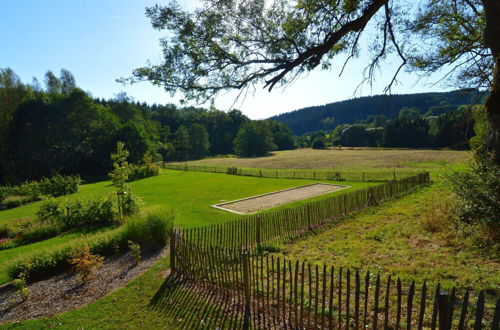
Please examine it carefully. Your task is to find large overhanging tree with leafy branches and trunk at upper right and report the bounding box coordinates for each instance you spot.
[122,0,500,162]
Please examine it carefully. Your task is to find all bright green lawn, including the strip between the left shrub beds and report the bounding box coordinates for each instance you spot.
[0,171,373,284]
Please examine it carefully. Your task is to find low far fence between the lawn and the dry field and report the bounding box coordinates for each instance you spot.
[163,163,417,182]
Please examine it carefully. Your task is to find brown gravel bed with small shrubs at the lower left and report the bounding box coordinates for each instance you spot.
[0,249,166,324]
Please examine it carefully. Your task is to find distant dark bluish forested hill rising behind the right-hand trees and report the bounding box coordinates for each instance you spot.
[269,90,484,135]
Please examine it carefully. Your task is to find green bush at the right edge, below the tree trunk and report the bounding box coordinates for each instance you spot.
[449,157,500,229]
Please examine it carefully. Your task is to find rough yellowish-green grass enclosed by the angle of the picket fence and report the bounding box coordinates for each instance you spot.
[278,182,500,296]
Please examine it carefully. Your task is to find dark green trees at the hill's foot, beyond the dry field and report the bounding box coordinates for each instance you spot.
[297,103,478,149]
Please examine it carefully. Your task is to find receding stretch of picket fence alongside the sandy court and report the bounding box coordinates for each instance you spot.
[179,172,429,249]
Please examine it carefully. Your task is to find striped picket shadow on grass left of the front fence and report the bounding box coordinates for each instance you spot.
[149,274,243,329]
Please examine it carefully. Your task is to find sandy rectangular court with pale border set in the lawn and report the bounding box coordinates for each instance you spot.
[212,183,349,214]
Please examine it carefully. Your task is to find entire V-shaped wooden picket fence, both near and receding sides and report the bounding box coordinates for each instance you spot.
[166,173,500,329]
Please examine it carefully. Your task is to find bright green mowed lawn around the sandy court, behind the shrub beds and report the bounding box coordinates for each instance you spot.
[0,170,368,228]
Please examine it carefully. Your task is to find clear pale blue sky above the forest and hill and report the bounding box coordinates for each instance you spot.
[0,0,445,119]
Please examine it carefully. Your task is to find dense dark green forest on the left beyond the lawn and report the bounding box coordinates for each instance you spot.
[0,69,294,183]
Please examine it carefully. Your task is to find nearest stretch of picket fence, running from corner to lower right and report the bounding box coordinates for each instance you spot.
[172,237,500,329]
